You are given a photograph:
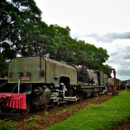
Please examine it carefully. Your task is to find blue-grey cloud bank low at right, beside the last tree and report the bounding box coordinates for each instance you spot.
[106,40,130,80]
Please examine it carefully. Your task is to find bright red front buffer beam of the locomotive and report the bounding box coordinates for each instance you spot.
[0,93,26,109]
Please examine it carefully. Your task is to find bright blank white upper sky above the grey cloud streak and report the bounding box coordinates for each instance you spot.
[35,0,130,34]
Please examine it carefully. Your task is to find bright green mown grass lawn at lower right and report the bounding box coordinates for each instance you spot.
[48,91,130,130]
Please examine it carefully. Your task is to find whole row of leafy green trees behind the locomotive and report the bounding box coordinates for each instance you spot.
[0,0,111,77]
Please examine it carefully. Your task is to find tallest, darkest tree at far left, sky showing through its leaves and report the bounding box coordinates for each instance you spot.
[0,0,41,59]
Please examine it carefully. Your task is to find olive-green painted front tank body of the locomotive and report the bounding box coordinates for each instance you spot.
[8,56,77,85]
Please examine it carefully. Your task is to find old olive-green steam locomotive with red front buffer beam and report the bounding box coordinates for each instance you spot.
[0,56,112,113]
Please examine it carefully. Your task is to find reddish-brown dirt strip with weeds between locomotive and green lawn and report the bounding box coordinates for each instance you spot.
[10,94,111,130]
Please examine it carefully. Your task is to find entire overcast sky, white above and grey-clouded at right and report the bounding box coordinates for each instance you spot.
[35,0,130,80]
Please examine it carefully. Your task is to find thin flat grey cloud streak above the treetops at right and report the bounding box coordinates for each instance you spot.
[86,32,130,42]
